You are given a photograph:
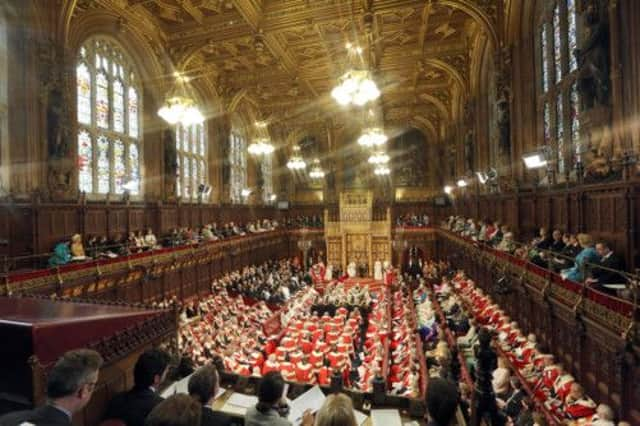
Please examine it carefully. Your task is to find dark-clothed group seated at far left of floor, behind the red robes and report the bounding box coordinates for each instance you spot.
[212,259,309,304]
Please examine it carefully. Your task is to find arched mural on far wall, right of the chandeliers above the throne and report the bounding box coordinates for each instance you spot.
[389,129,427,187]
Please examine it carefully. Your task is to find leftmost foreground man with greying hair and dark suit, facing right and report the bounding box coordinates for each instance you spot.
[0,349,102,426]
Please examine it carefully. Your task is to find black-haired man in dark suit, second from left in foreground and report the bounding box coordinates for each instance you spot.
[105,349,171,426]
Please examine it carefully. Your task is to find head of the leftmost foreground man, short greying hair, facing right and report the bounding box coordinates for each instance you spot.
[47,349,103,413]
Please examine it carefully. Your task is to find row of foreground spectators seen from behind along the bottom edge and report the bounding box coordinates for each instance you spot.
[0,322,470,426]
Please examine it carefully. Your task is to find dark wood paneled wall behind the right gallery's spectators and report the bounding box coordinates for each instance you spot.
[424,181,640,270]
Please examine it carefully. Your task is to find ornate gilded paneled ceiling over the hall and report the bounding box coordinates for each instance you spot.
[69,0,499,146]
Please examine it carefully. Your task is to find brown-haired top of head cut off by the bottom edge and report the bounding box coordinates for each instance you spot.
[144,394,202,426]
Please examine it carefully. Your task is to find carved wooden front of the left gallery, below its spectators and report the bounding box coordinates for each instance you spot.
[0,231,289,303]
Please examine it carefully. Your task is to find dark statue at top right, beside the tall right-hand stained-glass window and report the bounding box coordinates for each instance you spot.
[575,0,609,111]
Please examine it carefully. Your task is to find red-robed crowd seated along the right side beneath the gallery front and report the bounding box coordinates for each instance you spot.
[434,272,623,425]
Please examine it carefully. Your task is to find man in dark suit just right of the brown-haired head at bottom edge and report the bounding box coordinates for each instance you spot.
[188,364,231,426]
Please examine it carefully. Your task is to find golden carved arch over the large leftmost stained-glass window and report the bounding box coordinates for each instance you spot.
[65,10,168,102]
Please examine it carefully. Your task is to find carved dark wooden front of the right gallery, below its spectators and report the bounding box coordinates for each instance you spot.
[436,229,640,424]
